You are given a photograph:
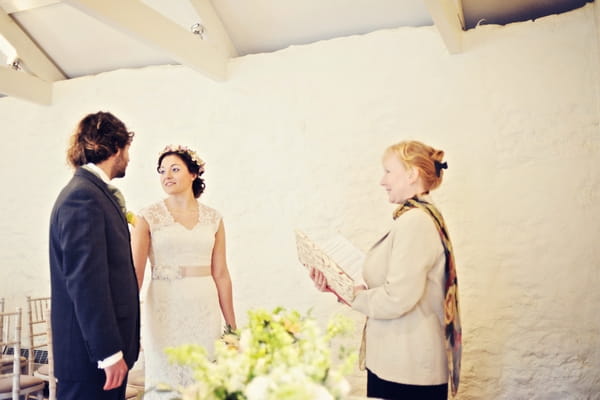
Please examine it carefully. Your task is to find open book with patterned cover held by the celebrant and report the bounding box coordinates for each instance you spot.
[296,230,365,304]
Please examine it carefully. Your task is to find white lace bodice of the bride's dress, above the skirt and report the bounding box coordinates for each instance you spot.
[141,201,221,280]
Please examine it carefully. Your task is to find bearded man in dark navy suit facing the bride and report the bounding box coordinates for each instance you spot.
[50,112,140,400]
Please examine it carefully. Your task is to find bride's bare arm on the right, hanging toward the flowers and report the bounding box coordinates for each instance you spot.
[211,221,236,329]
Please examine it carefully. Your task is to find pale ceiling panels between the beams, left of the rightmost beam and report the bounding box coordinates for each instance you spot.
[4,0,432,78]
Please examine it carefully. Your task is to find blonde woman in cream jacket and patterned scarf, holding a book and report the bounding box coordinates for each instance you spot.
[311,141,461,400]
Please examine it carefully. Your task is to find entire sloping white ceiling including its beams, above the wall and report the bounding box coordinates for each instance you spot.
[0,0,591,103]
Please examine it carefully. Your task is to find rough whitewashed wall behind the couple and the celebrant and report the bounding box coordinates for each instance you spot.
[0,3,600,399]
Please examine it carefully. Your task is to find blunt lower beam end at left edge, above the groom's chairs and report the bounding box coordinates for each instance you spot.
[0,66,52,105]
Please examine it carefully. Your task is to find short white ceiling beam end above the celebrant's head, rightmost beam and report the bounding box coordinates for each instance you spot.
[424,0,464,54]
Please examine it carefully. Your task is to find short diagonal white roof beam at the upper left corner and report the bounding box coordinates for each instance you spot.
[0,9,66,82]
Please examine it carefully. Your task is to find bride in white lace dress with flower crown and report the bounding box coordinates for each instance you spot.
[132,145,236,399]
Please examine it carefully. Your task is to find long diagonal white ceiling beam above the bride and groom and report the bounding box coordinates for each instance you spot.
[64,0,229,81]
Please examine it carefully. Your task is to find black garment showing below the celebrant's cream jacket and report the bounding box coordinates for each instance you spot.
[367,369,448,400]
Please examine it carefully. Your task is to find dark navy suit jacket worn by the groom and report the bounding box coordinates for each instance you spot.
[50,168,140,381]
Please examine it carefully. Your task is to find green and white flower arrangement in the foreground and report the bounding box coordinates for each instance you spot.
[166,308,357,400]
